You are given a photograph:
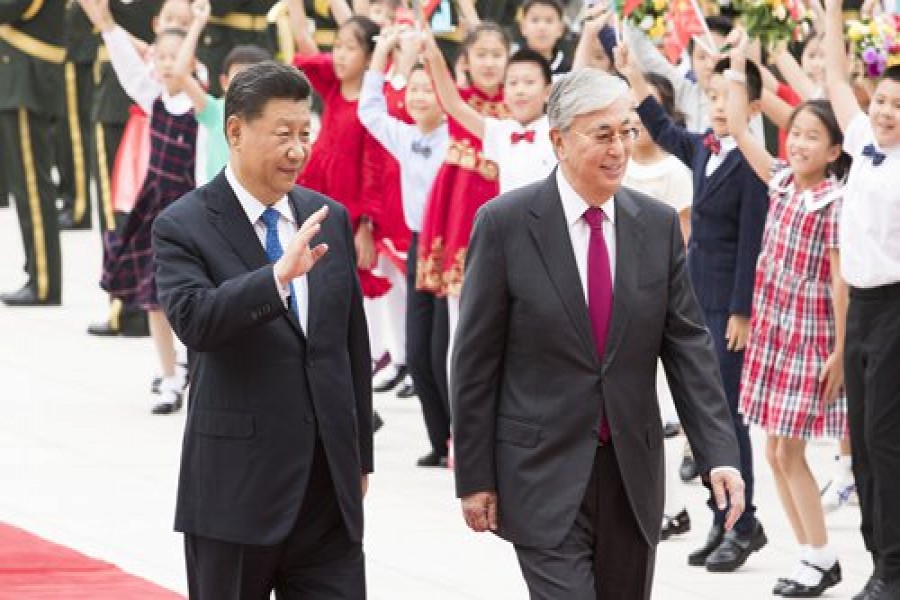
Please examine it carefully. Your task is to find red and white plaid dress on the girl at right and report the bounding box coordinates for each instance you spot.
[740,161,847,439]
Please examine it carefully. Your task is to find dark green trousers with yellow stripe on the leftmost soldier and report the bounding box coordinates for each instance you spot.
[0,108,62,302]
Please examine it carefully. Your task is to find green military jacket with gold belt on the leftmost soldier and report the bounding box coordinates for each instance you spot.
[0,0,66,117]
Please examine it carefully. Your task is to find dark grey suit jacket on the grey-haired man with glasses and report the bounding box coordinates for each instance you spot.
[451,173,740,548]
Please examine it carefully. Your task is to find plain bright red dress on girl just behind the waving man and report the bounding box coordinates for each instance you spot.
[294,54,410,298]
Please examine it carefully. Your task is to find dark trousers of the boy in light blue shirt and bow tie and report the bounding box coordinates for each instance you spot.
[406,234,450,456]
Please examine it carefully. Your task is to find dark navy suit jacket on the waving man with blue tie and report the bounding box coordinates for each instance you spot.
[153,173,372,545]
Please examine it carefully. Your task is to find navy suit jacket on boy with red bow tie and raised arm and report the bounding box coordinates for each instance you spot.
[637,96,769,317]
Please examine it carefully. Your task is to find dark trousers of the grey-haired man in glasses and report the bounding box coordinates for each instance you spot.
[516,445,656,600]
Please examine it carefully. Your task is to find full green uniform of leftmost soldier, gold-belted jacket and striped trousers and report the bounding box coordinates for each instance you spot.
[0,0,66,305]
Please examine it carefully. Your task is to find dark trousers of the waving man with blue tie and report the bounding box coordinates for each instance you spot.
[184,441,366,600]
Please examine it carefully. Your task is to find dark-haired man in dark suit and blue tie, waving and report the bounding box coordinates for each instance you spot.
[153,62,372,600]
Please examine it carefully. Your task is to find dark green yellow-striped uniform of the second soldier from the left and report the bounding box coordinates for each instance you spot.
[56,0,98,229]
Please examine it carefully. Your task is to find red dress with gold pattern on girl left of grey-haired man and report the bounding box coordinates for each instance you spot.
[416,87,508,296]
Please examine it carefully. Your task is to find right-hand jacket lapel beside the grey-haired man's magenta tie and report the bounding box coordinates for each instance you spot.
[602,188,644,372]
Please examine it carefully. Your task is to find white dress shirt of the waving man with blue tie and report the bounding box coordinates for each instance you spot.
[225,164,309,332]
